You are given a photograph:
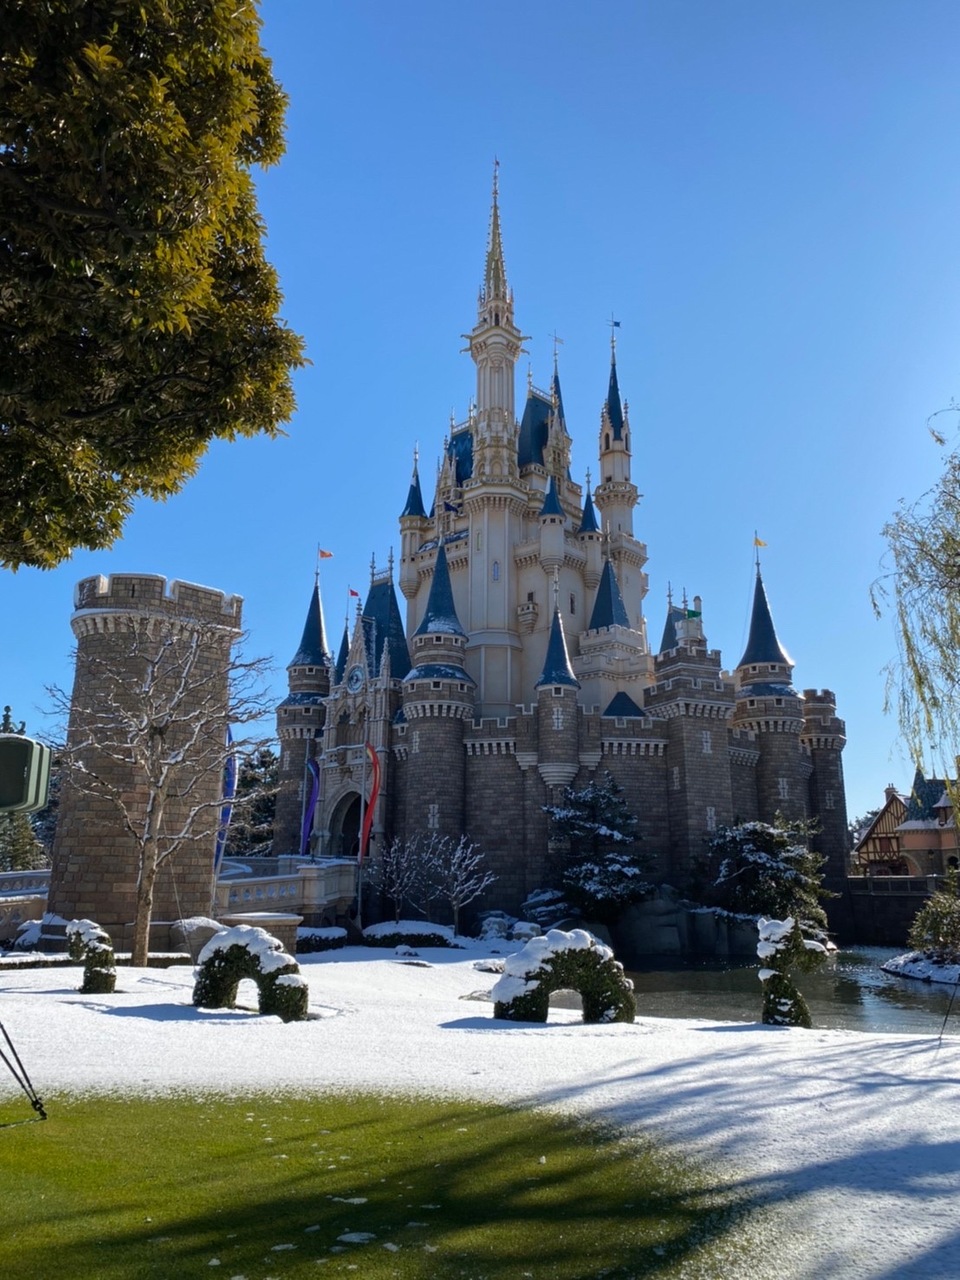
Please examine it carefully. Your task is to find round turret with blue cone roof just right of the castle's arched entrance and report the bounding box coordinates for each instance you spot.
[403,545,476,840]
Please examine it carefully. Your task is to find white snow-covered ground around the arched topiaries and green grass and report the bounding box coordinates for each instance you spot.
[0,943,960,1280]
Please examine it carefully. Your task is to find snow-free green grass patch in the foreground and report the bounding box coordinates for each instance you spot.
[0,1094,740,1280]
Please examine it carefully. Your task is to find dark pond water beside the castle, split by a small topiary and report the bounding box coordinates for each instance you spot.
[630,947,960,1036]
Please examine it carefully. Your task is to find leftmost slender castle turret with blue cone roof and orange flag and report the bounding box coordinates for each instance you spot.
[274,576,333,854]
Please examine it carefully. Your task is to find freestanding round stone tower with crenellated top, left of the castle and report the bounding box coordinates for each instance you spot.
[47,573,242,946]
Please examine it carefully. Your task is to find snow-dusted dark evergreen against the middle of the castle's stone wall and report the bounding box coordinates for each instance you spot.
[544,773,652,920]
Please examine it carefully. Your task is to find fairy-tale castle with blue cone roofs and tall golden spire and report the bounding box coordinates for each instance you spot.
[274,179,847,911]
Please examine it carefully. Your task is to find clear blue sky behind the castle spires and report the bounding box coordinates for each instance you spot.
[0,0,960,814]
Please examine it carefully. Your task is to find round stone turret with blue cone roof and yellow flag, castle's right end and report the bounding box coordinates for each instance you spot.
[733,563,812,822]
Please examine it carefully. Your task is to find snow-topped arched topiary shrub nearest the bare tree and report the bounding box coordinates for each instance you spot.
[193,924,308,1023]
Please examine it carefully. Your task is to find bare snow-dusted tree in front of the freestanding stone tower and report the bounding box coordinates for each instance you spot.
[47,617,269,965]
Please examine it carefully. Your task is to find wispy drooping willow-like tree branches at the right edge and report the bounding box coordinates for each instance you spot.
[872,404,960,777]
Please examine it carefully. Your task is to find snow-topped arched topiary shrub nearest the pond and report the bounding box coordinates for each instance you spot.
[490,929,636,1023]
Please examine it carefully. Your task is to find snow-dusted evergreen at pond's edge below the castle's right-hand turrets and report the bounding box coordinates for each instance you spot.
[699,819,831,937]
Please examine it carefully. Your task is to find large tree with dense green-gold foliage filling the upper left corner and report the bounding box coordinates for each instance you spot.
[0,0,303,568]
